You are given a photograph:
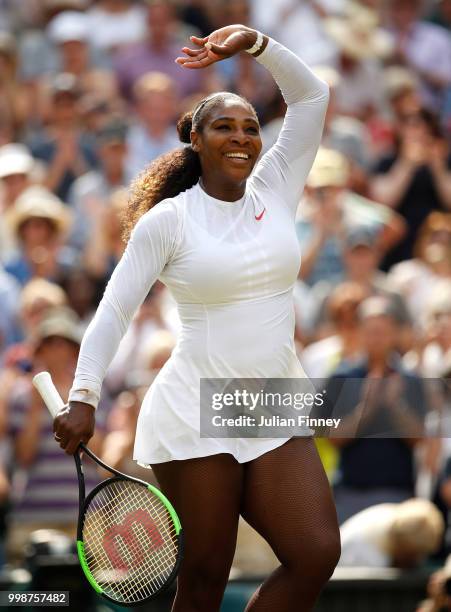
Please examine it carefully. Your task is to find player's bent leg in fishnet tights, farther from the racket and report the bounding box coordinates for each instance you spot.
[242,438,340,612]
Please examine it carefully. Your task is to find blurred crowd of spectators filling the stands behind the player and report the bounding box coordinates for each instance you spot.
[0,0,451,596]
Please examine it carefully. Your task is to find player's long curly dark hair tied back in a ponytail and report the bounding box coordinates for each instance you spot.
[122,91,257,241]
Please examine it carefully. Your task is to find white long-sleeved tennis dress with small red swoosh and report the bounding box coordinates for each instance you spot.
[69,39,328,464]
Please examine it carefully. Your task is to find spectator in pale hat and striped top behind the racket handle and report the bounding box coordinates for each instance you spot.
[8,309,105,561]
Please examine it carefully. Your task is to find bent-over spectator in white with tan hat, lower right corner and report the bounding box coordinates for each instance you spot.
[339,499,444,569]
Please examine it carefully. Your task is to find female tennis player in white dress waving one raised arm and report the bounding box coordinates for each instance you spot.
[55,25,340,612]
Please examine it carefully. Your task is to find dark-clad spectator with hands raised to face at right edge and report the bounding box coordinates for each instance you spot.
[371,110,451,270]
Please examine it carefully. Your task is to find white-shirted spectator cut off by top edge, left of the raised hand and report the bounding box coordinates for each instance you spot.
[87,0,146,54]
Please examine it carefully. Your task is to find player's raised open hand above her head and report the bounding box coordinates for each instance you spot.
[175,25,257,69]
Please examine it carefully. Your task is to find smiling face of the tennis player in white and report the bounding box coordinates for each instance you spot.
[191,96,262,185]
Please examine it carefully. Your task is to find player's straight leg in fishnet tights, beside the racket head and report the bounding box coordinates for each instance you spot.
[152,454,243,612]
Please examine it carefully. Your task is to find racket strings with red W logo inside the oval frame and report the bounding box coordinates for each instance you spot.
[83,481,178,603]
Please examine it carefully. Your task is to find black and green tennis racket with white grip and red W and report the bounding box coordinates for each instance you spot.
[33,372,183,606]
